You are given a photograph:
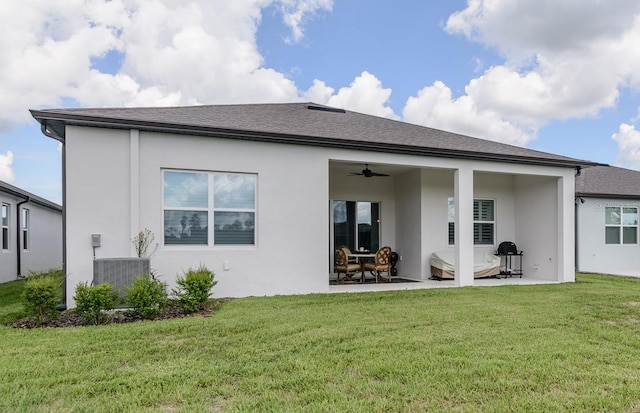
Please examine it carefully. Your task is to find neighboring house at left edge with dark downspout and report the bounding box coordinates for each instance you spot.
[0,181,62,282]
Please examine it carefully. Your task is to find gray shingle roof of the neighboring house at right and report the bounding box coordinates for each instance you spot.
[576,166,640,198]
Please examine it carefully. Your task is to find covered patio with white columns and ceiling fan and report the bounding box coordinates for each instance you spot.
[328,154,575,286]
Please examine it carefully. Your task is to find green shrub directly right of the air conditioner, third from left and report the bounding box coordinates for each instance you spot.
[126,275,168,318]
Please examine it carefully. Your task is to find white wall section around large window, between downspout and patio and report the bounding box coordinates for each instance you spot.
[139,132,329,297]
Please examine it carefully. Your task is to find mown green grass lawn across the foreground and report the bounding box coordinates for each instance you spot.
[0,275,640,412]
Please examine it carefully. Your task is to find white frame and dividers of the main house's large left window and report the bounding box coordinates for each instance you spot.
[161,168,258,248]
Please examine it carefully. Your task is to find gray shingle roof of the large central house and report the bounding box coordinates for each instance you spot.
[31,103,593,166]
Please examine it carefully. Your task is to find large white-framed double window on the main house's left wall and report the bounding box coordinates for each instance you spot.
[163,171,257,245]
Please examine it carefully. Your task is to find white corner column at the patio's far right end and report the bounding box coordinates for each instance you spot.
[558,174,576,282]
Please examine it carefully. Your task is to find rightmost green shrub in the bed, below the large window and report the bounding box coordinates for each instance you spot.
[172,264,218,312]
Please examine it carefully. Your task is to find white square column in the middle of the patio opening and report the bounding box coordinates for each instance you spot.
[454,168,473,287]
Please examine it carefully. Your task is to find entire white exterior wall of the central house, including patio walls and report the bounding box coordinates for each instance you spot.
[65,122,573,306]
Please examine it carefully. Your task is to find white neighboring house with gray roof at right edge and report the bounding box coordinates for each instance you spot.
[576,166,640,276]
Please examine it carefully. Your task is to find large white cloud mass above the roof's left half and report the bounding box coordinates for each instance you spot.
[0,0,333,130]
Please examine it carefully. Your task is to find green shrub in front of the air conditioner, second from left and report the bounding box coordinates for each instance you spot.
[73,282,118,325]
